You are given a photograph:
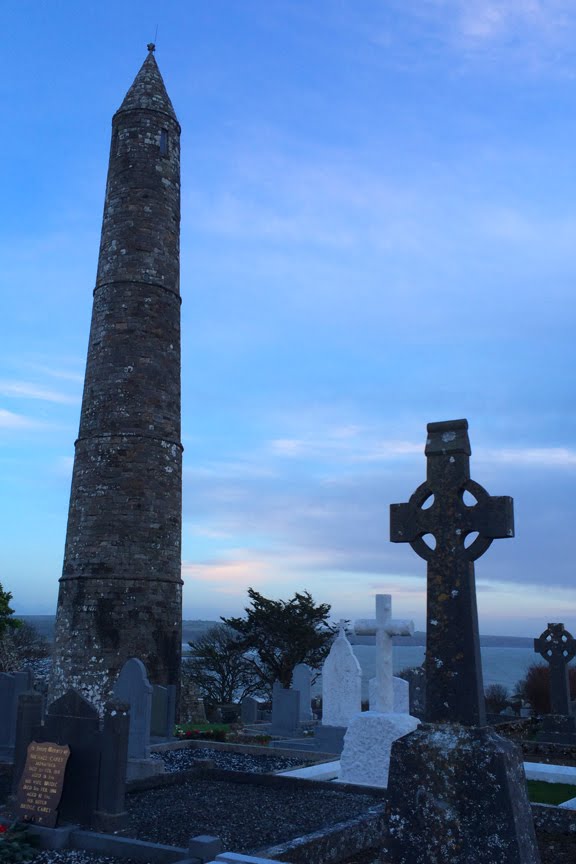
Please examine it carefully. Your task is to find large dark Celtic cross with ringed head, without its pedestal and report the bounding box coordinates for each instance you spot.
[390,420,514,726]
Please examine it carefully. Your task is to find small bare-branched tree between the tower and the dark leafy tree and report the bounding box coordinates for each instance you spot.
[182,624,261,705]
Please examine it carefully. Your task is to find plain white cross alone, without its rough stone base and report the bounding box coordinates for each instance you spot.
[354,594,414,714]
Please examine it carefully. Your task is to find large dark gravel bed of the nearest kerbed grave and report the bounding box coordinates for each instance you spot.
[127,779,382,852]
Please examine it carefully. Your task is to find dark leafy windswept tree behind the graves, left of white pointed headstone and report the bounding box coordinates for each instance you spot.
[222,588,335,691]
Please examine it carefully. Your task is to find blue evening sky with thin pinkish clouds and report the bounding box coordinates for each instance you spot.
[0,0,576,635]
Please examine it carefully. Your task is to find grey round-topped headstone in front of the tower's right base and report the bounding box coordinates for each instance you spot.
[114,657,152,759]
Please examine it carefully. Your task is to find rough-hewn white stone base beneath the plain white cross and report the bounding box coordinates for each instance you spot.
[338,711,420,788]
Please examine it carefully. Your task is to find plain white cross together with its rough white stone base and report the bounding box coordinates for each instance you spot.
[339,594,419,786]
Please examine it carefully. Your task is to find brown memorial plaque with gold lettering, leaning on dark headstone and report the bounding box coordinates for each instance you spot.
[16,741,70,828]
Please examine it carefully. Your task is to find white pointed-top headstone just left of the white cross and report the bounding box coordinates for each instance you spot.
[322,623,362,726]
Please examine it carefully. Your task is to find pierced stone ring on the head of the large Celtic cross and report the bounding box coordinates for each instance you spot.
[409,480,494,561]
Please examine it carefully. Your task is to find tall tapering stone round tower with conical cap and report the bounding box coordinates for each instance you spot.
[51,45,182,709]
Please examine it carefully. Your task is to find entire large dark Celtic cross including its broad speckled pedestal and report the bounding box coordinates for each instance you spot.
[384,420,540,864]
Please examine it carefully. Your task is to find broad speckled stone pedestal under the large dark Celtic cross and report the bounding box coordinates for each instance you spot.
[384,724,540,864]
